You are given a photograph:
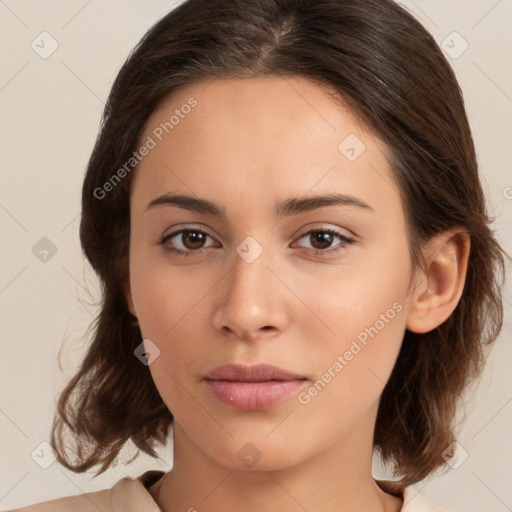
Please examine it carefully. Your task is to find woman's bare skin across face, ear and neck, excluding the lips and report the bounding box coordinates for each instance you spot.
[126,77,469,512]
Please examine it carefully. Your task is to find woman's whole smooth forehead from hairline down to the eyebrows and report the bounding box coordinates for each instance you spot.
[130,76,399,222]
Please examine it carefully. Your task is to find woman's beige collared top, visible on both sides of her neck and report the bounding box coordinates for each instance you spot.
[6,470,447,512]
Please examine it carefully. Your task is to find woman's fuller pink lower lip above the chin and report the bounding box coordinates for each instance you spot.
[205,379,306,410]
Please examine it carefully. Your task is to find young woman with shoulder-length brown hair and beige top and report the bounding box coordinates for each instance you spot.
[7,0,503,512]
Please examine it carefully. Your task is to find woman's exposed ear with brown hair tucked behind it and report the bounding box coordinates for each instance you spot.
[406,227,470,333]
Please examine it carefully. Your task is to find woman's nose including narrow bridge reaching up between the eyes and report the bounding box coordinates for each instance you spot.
[215,237,285,339]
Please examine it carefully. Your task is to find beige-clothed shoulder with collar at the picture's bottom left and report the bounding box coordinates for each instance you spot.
[6,471,165,512]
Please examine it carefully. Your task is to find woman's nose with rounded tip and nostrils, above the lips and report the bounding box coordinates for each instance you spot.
[214,245,290,341]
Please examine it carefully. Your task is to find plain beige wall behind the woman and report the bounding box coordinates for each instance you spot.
[0,0,512,512]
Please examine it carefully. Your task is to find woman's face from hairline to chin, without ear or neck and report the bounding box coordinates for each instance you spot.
[128,77,415,469]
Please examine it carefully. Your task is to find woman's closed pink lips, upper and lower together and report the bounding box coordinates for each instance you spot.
[204,364,308,410]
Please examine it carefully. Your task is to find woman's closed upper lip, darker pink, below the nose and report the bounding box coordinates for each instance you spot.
[204,364,305,382]
